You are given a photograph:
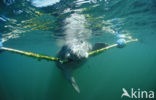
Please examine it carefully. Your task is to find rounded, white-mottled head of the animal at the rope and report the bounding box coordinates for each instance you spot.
[60,39,92,61]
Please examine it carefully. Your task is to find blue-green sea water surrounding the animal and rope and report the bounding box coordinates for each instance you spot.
[0,0,156,100]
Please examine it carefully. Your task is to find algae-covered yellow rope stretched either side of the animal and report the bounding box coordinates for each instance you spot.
[1,39,138,63]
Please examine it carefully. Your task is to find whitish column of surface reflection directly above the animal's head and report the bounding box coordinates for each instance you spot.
[64,13,91,40]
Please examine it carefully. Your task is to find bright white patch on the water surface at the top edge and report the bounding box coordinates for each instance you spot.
[30,0,60,7]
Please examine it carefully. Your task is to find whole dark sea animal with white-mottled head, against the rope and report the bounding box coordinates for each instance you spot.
[56,40,108,93]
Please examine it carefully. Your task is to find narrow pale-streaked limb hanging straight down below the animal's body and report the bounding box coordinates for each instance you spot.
[64,72,80,93]
